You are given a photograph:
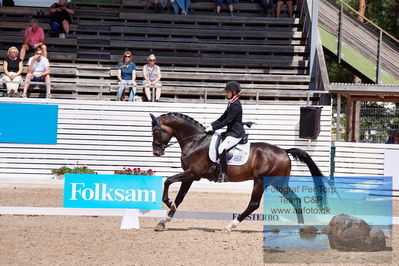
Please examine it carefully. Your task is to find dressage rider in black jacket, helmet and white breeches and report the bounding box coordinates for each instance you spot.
[205,81,246,182]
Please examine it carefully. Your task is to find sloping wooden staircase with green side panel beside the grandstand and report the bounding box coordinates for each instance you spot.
[319,0,399,85]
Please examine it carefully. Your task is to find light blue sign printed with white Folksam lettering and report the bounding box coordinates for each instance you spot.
[64,174,162,210]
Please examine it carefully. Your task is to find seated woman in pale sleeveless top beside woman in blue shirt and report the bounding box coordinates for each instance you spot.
[142,54,162,102]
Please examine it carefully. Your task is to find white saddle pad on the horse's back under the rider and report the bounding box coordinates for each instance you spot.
[208,132,251,165]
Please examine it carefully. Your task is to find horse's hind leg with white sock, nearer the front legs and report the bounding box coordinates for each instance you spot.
[224,178,264,232]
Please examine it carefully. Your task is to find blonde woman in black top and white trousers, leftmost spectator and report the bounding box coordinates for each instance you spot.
[3,46,23,97]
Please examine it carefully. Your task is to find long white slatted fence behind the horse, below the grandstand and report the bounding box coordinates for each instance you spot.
[0,98,331,181]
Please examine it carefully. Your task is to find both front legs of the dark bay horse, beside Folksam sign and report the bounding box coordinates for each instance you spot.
[156,172,194,230]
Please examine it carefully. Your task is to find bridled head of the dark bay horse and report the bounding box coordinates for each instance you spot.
[150,113,172,157]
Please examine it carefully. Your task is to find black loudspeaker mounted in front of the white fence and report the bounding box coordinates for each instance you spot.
[299,106,322,139]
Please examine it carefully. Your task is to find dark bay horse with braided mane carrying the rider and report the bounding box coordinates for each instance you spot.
[150,113,325,231]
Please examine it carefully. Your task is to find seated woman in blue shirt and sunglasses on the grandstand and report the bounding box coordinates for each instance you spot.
[116,51,137,102]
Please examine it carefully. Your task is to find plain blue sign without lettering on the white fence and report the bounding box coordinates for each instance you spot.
[0,103,58,144]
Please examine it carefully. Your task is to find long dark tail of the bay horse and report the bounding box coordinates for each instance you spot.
[285,148,327,208]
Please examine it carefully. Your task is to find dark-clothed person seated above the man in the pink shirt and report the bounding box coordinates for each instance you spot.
[50,0,75,39]
